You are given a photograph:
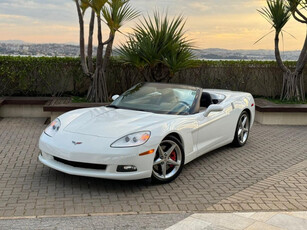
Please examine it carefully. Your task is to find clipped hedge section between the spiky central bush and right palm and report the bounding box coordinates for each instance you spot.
[173,61,307,97]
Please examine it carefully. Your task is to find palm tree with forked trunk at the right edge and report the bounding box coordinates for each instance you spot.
[259,0,307,101]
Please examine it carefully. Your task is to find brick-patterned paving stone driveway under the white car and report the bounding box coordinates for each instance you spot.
[0,118,307,218]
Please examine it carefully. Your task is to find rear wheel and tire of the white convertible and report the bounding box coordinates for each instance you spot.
[232,111,250,147]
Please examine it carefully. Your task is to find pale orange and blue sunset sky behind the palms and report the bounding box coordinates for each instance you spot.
[0,0,306,50]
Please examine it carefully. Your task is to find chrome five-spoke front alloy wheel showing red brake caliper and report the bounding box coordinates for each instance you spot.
[153,139,182,180]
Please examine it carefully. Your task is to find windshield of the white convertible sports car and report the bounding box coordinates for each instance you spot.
[110,83,198,115]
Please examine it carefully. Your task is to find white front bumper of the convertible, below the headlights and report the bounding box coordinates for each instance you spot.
[38,132,157,180]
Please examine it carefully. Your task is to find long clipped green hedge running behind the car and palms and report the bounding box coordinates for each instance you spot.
[0,56,307,97]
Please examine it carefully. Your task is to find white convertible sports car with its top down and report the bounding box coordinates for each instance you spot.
[39,83,255,183]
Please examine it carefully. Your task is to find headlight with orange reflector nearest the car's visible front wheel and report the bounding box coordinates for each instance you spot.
[111,131,150,148]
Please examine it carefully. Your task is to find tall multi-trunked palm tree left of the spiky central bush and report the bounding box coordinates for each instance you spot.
[74,0,139,102]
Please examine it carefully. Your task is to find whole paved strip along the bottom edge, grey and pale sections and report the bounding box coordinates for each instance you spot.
[0,211,307,230]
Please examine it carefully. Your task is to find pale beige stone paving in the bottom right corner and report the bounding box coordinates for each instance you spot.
[167,211,307,230]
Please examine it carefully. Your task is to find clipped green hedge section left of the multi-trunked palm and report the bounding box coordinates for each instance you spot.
[0,56,84,96]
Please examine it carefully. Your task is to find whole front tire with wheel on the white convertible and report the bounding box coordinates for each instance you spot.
[151,136,184,183]
